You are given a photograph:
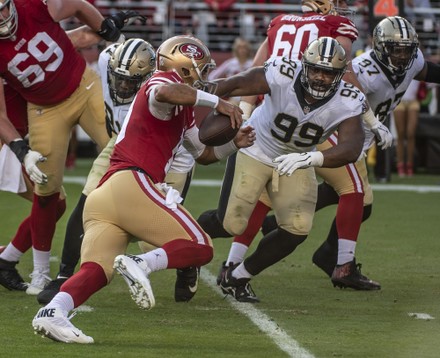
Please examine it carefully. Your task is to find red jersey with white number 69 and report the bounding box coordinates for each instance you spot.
[0,0,86,105]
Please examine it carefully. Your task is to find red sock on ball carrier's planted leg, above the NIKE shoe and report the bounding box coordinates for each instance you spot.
[60,262,108,308]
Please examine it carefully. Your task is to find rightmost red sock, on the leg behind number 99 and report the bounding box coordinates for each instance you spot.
[336,193,364,241]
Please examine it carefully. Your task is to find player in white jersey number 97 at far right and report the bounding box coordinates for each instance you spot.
[315,16,440,280]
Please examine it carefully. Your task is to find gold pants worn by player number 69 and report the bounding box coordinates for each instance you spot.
[28,68,110,196]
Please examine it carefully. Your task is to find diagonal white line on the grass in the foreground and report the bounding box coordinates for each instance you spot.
[200,269,315,358]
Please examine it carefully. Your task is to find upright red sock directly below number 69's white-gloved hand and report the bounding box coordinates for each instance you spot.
[30,193,60,251]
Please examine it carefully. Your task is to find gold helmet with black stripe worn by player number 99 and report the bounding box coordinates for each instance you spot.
[301,37,347,99]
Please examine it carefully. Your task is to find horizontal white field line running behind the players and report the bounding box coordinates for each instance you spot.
[64,176,440,193]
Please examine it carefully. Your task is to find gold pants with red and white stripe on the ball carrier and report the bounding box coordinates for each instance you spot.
[81,170,212,280]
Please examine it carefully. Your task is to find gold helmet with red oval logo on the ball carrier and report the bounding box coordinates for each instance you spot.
[156,36,215,92]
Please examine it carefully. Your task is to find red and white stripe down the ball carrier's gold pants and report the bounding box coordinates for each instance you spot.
[133,171,209,244]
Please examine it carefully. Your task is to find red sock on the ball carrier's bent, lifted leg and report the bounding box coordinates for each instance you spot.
[162,239,214,268]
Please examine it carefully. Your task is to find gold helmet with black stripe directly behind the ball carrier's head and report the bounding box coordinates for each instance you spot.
[107,39,156,105]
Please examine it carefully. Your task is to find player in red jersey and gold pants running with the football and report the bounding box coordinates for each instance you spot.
[32,36,255,343]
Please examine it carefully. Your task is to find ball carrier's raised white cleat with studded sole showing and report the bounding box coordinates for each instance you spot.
[113,255,156,310]
